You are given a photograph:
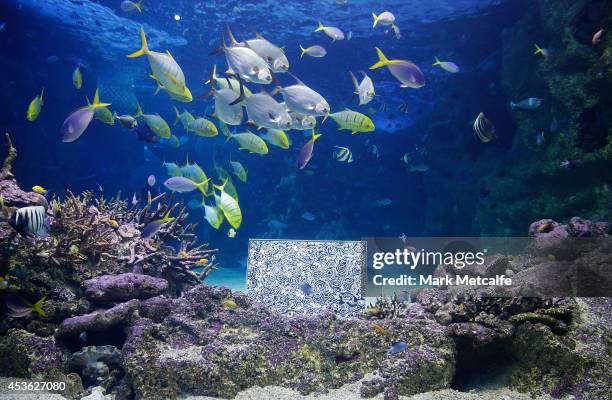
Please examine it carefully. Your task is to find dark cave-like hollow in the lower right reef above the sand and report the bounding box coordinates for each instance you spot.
[451,337,516,392]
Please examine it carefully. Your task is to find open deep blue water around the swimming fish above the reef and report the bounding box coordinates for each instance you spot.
[0,0,528,288]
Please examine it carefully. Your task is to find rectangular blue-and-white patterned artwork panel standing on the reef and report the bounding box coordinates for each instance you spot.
[247,239,367,316]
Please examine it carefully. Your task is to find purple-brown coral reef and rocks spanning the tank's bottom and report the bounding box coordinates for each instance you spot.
[0,136,612,399]
